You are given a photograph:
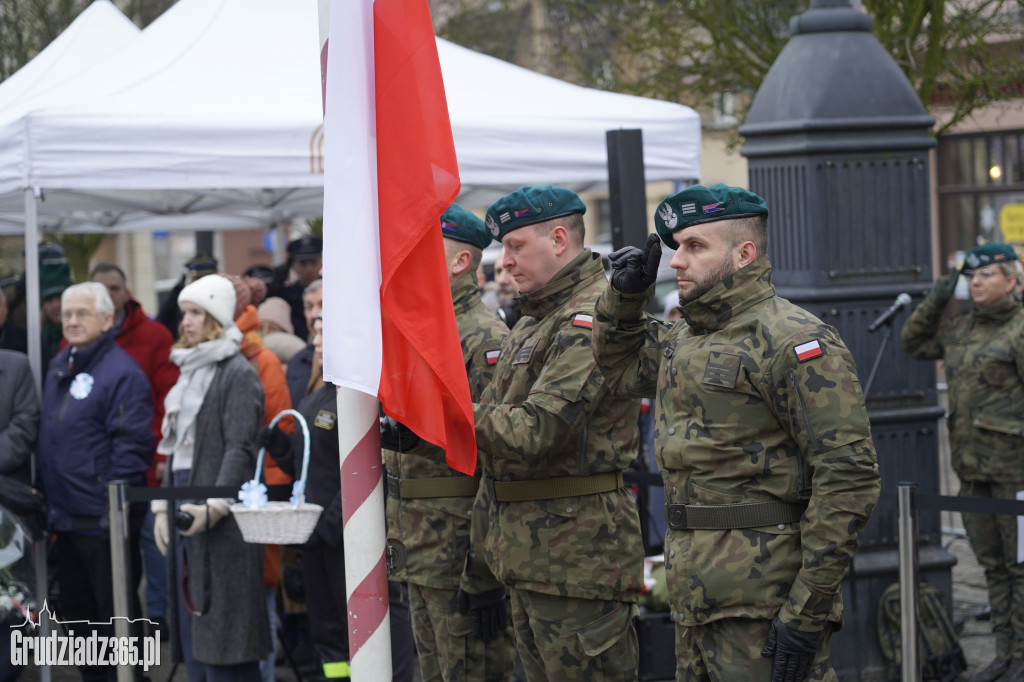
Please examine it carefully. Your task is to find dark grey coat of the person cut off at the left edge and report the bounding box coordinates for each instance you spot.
[0,350,39,483]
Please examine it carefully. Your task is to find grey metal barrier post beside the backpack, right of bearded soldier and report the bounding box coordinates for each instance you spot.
[896,482,922,682]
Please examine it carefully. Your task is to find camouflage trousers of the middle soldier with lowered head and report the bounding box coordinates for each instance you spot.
[509,588,639,682]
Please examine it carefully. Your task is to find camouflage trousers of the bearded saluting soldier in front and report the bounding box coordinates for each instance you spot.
[676,619,839,682]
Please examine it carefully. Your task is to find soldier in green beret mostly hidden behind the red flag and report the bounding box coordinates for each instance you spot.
[381,204,513,682]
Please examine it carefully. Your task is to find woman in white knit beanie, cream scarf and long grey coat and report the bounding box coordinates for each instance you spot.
[153,274,271,682]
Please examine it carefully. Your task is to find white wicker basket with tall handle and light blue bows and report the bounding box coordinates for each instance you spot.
[231,410,324,545]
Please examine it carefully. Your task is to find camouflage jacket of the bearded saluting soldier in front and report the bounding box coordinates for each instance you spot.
[594,256,880,632]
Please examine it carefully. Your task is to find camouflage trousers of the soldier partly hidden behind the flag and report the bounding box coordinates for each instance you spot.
[409,583,514,682]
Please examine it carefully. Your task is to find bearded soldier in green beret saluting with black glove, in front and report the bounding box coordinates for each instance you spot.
[594,184,880,682]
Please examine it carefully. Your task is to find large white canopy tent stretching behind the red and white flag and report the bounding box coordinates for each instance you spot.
[0,0,700,232]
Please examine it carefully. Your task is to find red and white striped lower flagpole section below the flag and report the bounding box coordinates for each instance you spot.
[338,387,391,682]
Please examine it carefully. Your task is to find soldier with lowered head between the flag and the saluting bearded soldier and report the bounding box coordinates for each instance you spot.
[463,185,643,682]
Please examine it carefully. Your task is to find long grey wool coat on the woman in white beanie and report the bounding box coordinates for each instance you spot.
[168,353,270,666]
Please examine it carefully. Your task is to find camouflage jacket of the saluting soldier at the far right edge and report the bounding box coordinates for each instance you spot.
[901,288,1024,483]
